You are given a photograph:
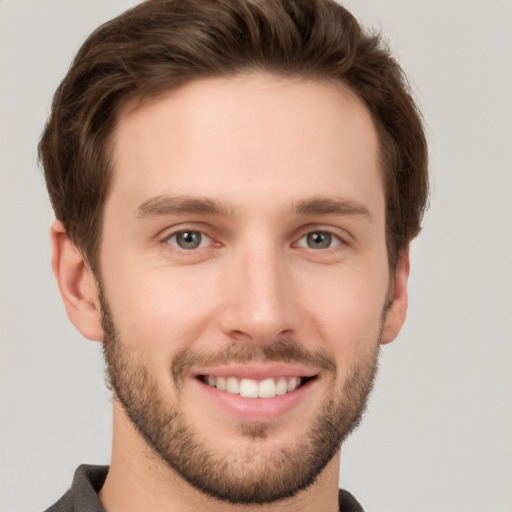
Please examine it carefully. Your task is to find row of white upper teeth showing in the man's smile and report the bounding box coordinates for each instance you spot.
[205,375,301,398]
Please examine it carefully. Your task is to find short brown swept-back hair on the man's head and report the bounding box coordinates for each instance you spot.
[39,0,428,270]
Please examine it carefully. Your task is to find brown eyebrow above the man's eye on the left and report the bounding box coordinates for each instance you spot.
[135,196,233,219]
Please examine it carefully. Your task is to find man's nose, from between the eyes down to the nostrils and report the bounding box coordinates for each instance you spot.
[220,246,299,345]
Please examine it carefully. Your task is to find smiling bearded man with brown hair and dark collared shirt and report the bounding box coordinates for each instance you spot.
[40,0,427,512]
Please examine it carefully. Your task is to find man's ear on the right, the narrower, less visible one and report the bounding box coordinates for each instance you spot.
[381,248,409,345]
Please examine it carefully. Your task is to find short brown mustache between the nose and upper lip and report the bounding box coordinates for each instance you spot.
[171,339,336,386]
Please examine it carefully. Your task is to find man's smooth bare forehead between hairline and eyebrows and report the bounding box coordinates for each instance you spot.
[106,74,383,216]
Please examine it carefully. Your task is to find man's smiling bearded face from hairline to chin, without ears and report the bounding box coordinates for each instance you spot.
[94,75,404,503]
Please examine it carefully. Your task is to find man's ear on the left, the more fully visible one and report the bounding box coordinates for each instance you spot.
[50,220,103,341]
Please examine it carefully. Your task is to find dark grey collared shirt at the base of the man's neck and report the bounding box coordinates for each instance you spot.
[45,464,364,512]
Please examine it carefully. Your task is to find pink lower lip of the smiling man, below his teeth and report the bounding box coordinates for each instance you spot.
[193,379,316,422]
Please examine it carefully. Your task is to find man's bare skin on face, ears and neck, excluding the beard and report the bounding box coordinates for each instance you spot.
[52,74,409,512]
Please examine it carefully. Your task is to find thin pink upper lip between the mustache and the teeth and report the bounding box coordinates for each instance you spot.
[189,363,318,380]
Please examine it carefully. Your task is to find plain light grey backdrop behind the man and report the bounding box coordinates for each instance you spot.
[0,0,512,512]
